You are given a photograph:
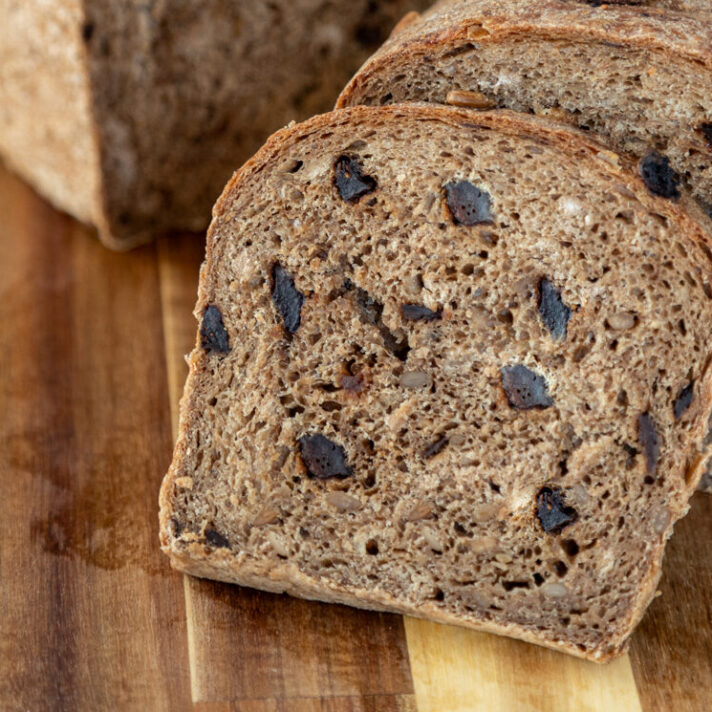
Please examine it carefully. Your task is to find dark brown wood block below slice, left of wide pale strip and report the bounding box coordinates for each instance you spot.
[186,580,412,701]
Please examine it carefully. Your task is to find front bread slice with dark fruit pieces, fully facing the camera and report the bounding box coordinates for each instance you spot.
[160,105,712,661]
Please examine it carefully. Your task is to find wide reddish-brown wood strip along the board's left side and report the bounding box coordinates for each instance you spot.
[0,170,191,710]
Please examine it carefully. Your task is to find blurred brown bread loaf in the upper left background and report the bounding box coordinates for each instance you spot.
[0,0,428,249]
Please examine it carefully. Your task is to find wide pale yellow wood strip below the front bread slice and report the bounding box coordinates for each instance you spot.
[405,618,641,712]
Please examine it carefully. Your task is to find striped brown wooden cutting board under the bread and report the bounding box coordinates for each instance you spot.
[0,164,712,712]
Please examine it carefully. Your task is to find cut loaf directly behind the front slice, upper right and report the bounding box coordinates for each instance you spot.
[338,0,712,217]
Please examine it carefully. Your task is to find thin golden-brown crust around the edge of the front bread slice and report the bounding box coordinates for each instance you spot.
[160,105,712,662]
